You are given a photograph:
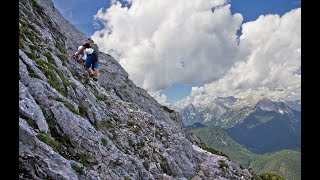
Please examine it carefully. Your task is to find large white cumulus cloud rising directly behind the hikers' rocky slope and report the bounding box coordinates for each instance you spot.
[92,0,243,92]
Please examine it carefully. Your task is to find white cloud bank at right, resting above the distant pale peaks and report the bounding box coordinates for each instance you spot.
[172,8,301,106]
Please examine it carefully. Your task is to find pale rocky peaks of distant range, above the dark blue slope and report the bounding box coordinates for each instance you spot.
[179,93,301,129]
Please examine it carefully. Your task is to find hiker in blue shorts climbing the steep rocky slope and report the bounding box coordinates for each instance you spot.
[72,38,99,81]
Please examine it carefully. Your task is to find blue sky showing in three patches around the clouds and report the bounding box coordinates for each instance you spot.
[53,0,301,103]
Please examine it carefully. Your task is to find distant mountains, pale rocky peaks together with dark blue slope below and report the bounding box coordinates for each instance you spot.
[180,94,301,154]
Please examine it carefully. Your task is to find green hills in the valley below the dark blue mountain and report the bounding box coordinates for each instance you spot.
[191,123,301,180]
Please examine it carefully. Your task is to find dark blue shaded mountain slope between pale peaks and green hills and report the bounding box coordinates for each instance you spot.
[227,109,301,153]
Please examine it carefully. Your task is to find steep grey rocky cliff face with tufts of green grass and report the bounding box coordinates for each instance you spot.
[19,0,251,179]
